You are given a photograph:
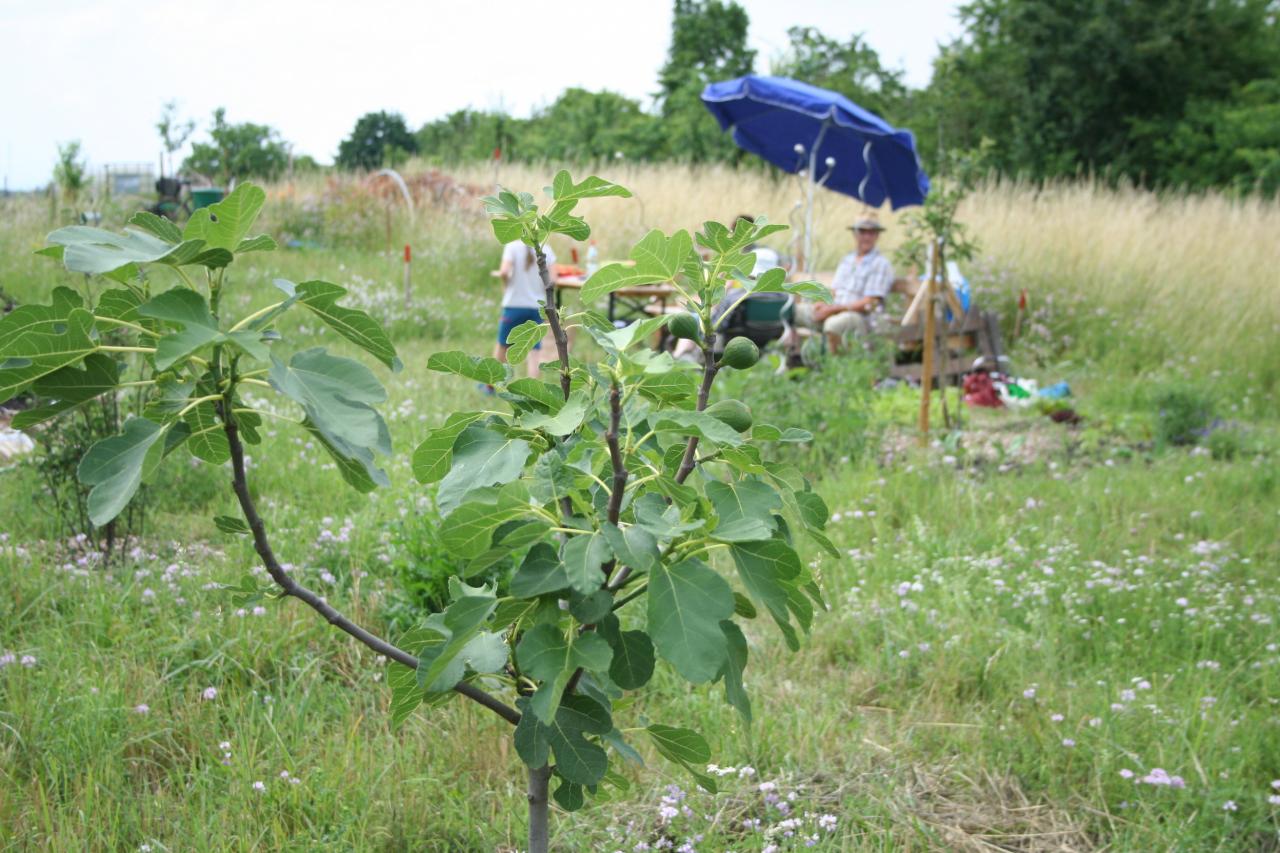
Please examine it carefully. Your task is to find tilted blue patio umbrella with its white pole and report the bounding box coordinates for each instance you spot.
[703,74,929,267]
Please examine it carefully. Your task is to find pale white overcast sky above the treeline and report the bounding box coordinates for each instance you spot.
[0,0,960,190]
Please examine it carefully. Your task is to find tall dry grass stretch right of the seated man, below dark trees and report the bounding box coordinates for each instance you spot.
[963,176,1280,360]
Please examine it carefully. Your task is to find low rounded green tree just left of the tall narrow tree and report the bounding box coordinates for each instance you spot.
[518,88,663,163]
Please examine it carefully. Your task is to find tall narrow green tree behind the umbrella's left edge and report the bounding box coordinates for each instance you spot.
[658,0,755,163]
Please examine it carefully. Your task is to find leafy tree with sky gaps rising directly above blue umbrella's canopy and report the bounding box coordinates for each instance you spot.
[772,27,908,122]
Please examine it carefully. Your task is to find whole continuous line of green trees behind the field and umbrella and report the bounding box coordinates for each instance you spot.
[399,0,1280,192]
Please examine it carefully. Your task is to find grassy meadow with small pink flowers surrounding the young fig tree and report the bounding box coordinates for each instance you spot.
[0,167,1280,850]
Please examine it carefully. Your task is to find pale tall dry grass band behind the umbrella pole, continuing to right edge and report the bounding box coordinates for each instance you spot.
[437,164,1280,376]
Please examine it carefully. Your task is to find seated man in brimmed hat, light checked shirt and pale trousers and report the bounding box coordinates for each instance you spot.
[783,219,893,352]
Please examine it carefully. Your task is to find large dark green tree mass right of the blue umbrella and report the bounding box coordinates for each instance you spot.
[933,0,1280,183]
